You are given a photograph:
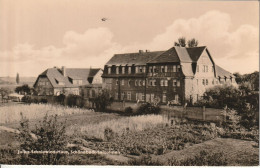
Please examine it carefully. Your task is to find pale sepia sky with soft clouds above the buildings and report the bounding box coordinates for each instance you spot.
[0,0,259,77]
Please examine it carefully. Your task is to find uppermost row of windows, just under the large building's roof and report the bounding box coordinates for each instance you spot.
[108,65,181,74]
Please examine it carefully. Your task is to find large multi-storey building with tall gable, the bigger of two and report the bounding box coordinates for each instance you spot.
[102,46,236,104]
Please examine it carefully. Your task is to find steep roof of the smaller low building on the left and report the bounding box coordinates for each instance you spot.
[35,68,101,87]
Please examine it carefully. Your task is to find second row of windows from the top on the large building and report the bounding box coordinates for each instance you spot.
[116,79,181,86]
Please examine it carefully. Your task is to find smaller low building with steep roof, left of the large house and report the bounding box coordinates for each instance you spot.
[34,66,103,96]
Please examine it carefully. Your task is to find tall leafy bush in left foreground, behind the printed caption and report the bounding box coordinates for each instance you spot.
[18,114,68,165]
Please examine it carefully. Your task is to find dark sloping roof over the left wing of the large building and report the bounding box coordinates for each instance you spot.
[106,51,163,66]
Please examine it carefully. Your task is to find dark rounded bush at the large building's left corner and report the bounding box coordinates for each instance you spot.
[94,90,113,110]
